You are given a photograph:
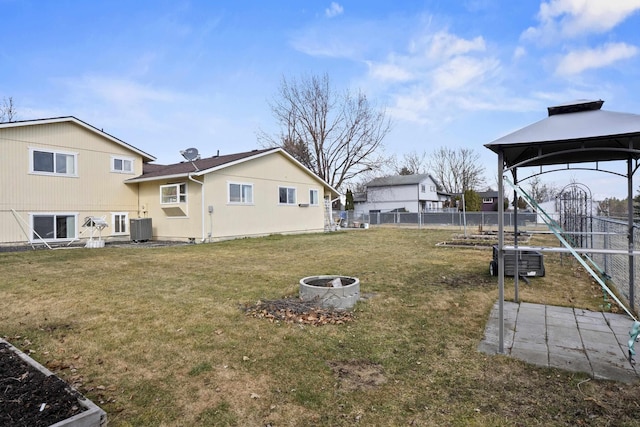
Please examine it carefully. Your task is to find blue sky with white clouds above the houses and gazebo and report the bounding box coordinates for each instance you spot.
[0,0,640,198]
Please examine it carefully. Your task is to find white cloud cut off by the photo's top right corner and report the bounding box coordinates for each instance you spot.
[522,0,640,42]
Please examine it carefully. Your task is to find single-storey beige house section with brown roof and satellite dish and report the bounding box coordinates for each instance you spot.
[127,148,339,242]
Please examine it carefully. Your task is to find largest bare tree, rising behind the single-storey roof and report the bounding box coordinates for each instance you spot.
[258,74,391,188]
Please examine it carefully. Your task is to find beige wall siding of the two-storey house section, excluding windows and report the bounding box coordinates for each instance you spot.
[0,122,142,243]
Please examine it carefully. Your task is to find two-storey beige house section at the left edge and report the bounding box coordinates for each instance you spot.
[0,117,155,244]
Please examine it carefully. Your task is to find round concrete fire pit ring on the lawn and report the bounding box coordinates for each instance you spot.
[300,275,360,309]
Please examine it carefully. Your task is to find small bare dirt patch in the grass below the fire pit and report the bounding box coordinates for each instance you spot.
[328,360,387,391]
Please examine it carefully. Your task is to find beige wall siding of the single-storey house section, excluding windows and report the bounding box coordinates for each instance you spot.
[140,152,330,241]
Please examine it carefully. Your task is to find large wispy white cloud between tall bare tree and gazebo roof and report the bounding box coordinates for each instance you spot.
[367,30,505,127]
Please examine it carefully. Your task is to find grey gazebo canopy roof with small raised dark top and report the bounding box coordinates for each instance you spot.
[485,100,640,168]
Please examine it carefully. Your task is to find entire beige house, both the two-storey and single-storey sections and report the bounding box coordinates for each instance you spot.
[0,117,339,245]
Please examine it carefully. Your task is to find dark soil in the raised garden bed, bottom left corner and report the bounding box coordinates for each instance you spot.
[0,342,85,427]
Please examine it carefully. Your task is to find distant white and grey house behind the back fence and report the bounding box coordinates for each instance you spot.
[354,174,449,213]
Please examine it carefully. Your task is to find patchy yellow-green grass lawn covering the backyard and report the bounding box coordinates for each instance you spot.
[0,228,640,427]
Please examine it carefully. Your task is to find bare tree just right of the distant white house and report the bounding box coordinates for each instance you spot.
[429,147,485,193]
